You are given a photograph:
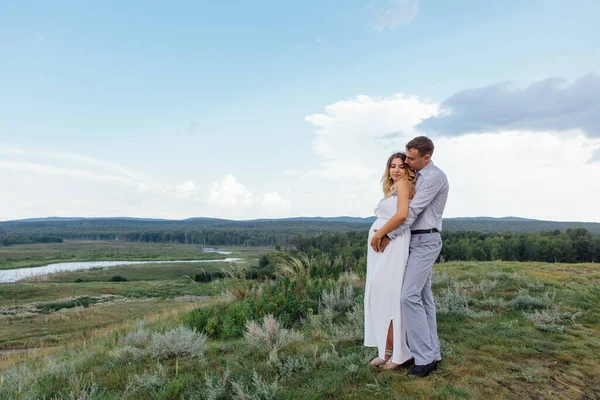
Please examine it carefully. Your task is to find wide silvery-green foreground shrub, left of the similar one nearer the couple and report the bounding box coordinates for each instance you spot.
[146,325,208,359]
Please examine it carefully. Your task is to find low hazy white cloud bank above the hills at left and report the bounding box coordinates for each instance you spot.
[0,144,291,220]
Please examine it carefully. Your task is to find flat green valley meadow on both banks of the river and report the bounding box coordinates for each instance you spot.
[0,241,269,350]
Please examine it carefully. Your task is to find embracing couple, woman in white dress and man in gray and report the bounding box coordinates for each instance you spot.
[365,136,449,377]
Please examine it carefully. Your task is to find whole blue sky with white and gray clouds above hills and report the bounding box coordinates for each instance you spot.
[0,0,600,222]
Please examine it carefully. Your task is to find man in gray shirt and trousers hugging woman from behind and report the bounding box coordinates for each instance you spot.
[378,136,449,377]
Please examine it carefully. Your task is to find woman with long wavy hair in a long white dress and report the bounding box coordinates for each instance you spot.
[365,153,416,369]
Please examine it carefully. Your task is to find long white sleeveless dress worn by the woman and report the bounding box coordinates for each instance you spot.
[365,195,411,364]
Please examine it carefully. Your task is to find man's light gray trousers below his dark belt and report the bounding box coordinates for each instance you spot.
[400,233,442,365]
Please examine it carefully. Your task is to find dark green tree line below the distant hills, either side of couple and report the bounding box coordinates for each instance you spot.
[0,221,600,263]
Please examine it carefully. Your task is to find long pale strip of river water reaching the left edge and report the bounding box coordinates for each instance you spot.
[0,258,242,283]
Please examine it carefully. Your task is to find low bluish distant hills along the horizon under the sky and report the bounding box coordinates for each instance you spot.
[0,216,600,233]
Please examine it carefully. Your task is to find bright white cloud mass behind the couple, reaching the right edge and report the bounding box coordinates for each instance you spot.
[304,95,600,221]
